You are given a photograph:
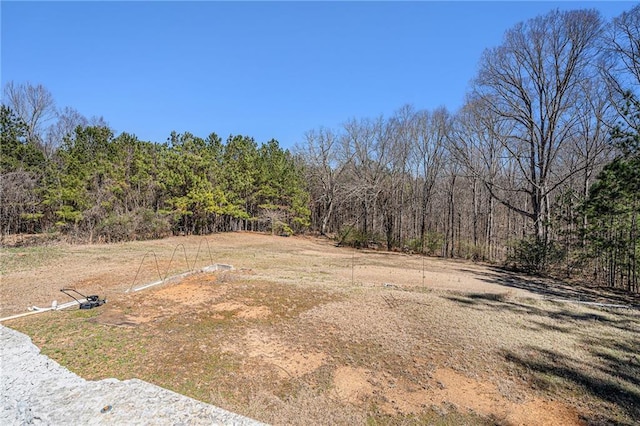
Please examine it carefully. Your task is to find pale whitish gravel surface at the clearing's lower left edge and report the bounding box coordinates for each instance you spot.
[0,325,262,426]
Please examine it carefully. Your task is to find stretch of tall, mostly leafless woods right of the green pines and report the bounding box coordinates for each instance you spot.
[299,6,640,292]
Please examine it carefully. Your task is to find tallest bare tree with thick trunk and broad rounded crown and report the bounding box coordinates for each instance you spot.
[474,10,602,246]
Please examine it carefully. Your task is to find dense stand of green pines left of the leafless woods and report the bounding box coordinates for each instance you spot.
[0,101,309,242]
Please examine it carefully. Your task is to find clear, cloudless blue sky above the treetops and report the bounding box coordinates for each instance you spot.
[0,1,634,148]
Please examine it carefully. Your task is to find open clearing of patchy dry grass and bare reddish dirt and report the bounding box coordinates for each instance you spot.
[0,233,640,425]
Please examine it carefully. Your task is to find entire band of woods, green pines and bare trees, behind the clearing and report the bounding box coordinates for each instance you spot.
[0,6,640,292]
